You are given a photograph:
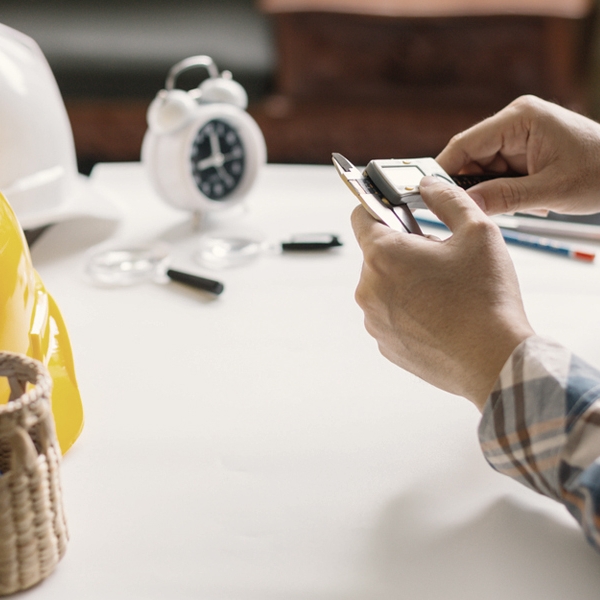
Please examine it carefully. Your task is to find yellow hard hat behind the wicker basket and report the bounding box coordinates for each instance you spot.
[0,194,83,454]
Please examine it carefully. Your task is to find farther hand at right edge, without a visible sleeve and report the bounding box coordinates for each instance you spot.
[437,96,600,215]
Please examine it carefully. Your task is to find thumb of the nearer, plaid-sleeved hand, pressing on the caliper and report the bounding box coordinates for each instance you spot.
[419,177,484,232]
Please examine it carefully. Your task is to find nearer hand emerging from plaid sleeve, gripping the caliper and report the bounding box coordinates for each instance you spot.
[352,177,533,410]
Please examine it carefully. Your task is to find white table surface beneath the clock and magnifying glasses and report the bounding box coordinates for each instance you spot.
[23,164,600,600]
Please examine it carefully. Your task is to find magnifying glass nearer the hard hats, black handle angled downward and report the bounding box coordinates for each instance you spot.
[85,244,224,295]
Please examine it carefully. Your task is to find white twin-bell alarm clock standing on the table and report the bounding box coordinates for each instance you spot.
[142,56,267,213]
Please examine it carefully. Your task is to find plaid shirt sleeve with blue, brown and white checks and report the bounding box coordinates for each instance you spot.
[479,336,600,551]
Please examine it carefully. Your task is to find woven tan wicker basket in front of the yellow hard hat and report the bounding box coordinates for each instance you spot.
[0,352,68,595]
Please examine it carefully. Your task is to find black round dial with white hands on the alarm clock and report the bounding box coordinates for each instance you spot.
[190,119,244,201]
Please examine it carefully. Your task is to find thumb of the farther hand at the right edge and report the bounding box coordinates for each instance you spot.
[467,173,553,215]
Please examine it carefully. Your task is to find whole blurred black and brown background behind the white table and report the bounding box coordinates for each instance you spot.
[0,0,600,173]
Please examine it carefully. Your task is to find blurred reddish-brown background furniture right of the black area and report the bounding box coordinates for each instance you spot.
[256,0,593,164]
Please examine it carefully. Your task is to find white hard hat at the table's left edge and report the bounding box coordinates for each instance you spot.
[0,24,118,229]
